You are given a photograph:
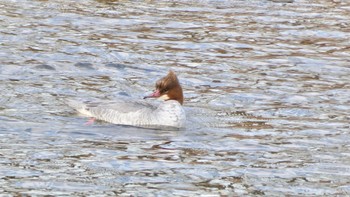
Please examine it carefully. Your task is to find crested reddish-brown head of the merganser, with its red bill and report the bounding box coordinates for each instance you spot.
[144,71,184,105]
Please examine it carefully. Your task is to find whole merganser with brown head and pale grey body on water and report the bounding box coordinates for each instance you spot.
[66,71,186,128]
